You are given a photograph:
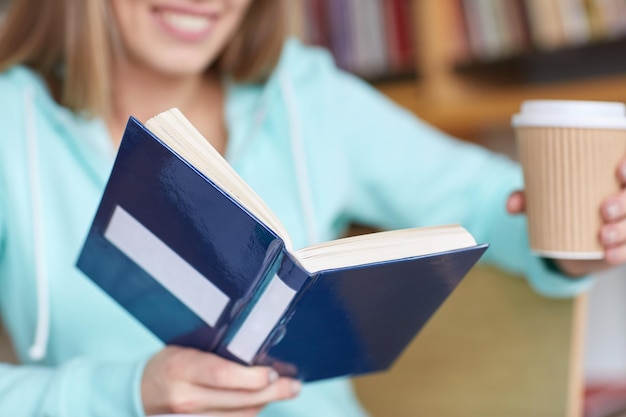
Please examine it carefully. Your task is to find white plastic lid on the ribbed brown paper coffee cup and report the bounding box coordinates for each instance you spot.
[512,100,626,129]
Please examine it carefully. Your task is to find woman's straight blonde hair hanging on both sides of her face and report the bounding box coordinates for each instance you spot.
[0,0,284,115]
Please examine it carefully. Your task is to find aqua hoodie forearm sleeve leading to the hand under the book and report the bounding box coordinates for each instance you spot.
[0,359,145,417]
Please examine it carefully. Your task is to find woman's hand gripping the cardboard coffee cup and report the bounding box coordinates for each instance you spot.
[507,159,626,277]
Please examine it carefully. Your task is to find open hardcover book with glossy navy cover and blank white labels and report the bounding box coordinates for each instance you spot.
[77,109,487,381]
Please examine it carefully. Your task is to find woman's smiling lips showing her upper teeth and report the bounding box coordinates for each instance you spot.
[155,9,216,42]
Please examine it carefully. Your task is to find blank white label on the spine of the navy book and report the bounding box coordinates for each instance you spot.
[227,275,296,363]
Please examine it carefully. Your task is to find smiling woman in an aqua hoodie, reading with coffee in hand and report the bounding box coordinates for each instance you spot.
[0,0,626,417]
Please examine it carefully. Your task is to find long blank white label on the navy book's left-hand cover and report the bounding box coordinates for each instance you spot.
[104,206,229,327]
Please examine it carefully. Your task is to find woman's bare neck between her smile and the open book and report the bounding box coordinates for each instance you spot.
[107,57,224,150]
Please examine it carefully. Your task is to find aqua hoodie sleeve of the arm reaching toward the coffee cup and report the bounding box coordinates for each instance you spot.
[280,42,592,297]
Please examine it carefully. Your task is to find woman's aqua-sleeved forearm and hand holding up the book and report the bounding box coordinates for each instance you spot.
[0,347,300,417]
